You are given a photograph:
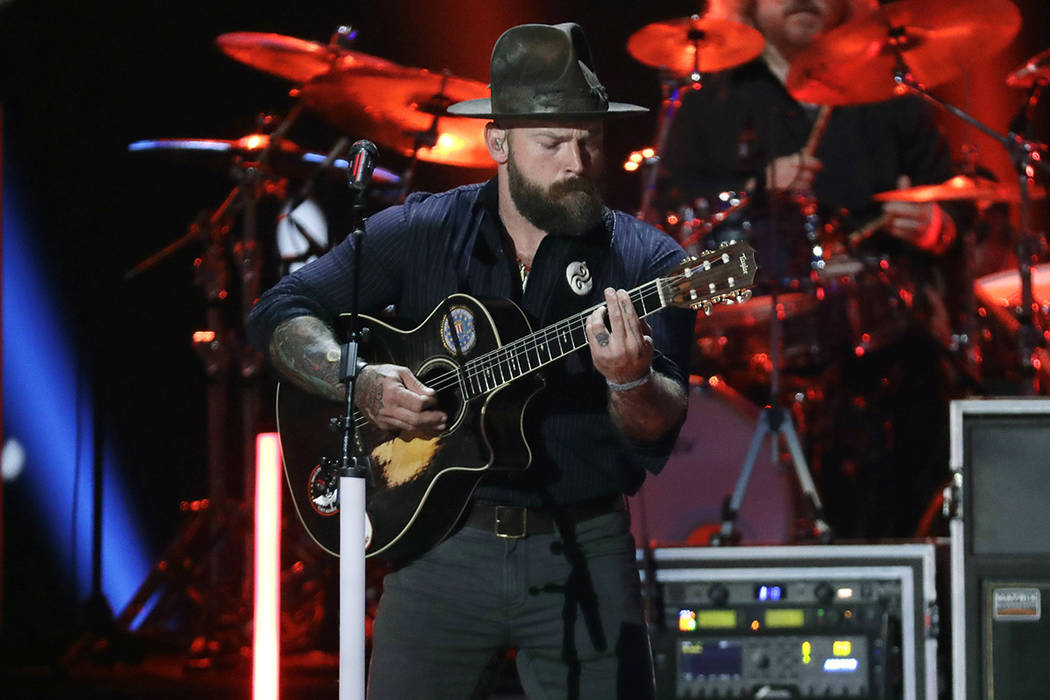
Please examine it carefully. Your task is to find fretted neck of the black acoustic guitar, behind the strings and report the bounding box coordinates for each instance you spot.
[464,279,668,397]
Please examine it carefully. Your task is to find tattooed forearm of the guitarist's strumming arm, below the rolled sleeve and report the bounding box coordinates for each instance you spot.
[270,316,345,399]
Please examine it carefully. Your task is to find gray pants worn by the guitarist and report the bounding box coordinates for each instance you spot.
[369,512,654,700]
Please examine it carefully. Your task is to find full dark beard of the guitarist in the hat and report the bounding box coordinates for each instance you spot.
[507,156,605,236]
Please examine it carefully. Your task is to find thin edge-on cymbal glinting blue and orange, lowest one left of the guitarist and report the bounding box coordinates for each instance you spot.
[128,133,401,185]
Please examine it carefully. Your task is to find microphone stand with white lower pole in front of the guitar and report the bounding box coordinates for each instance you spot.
[337,166,371,700]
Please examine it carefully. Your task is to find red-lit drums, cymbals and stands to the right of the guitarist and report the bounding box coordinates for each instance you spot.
[628,0,1050,544]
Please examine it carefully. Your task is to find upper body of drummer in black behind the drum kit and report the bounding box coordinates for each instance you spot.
[663,0,956,253]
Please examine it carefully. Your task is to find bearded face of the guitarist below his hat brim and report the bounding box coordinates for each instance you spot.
[506,122,605,235]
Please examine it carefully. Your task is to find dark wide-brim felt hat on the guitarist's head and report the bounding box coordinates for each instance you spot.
[448,23,649,120]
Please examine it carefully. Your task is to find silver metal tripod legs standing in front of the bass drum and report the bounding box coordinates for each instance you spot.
[711,406,832,547]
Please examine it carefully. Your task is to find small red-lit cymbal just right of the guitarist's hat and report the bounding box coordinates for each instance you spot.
[627,15,765,76]
